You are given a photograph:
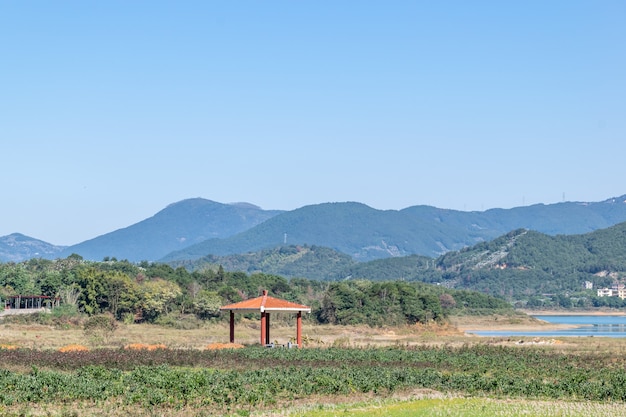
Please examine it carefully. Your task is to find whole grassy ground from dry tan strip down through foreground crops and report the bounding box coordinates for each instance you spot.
[0,317,626,417]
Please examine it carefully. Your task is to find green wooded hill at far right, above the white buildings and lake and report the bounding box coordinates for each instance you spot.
[437,223,626,308]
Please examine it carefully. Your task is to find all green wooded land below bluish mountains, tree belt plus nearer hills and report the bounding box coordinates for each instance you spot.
[0,223,626,326]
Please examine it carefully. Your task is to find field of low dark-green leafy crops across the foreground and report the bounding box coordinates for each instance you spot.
[0,344,626,416]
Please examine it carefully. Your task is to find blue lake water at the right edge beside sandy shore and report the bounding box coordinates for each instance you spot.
[466,315,626,337]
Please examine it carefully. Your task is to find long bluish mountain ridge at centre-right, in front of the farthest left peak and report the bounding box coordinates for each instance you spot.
[160,196,626,262]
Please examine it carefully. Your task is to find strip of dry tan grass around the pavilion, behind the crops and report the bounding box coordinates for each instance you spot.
[0,316,555,349]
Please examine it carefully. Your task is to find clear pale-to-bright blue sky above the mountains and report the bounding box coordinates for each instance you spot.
[0,0,626,245]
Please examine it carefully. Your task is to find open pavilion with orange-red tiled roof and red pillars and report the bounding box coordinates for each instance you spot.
[220,290,311,347]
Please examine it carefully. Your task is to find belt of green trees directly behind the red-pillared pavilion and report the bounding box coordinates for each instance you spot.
[0,256,511,326]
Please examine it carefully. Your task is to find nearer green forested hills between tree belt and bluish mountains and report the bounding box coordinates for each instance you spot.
[171,223,626,308]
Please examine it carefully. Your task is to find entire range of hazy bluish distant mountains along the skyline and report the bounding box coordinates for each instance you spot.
[0,196,626,262]
